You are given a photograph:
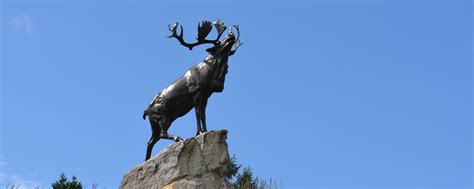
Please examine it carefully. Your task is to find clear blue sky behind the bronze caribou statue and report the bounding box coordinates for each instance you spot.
[0,1,473,188]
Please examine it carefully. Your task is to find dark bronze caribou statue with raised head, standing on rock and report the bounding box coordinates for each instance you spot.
[143,20,242,161]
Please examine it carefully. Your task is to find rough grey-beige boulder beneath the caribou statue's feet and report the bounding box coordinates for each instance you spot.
[120,130,232,189]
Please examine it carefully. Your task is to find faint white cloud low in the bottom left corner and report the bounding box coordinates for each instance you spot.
[0,161,42,189]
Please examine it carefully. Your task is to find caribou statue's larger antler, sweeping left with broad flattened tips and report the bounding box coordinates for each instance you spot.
[168,20,226,50]
